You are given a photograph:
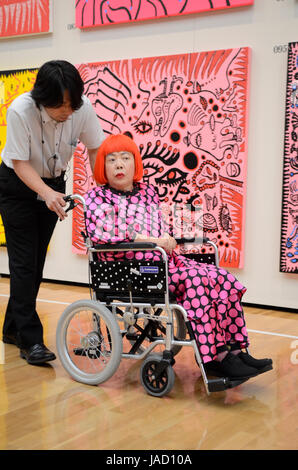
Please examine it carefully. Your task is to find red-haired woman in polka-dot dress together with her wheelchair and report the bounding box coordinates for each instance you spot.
[57,134,272,396]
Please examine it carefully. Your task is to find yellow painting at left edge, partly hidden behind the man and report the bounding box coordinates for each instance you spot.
[0,69,37,246]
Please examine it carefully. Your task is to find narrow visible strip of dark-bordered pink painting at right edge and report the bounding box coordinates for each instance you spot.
[280,42,298,273]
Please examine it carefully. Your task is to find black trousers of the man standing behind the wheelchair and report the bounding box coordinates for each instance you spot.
[0,163,65,348]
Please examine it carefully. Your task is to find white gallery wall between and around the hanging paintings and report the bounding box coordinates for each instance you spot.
[0,0,298,310]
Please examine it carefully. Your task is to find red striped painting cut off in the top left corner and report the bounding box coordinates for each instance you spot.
[0,0,50,37]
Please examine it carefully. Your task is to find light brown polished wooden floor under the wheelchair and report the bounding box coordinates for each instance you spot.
[0,279,298,450]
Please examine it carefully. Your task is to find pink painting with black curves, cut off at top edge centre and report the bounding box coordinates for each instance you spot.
[75,0,254,28]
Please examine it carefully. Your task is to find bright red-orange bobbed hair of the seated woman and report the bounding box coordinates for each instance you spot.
[93,134,143,184]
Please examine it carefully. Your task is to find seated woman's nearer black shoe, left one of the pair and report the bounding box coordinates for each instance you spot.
[204,352,259,379]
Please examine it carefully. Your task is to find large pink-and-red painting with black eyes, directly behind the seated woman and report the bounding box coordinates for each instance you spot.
[73,48,250,267]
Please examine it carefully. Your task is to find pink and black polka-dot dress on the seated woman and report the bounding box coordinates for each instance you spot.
[85,183,249,363]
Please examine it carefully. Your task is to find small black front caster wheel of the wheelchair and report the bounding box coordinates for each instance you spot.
[140,354,175,397]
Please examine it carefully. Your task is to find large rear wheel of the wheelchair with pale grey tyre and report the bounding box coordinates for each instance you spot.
[56,300,122,385]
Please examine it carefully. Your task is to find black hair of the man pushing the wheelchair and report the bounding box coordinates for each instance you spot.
[31,60,84,111]
